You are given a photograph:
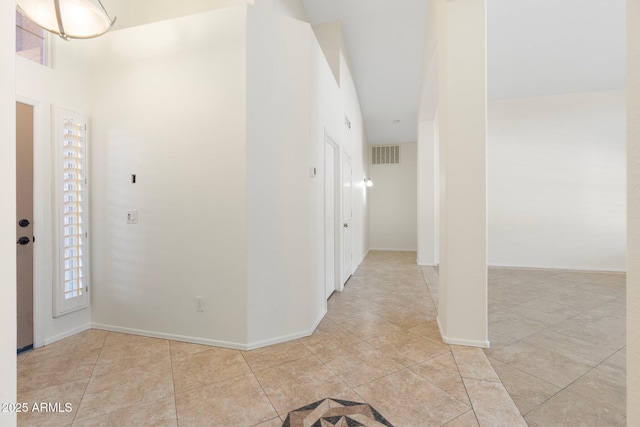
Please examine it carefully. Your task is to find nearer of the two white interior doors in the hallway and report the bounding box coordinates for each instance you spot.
[324,141,336,298]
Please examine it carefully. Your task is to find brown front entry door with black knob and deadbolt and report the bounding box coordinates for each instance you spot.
[16,102,33,351]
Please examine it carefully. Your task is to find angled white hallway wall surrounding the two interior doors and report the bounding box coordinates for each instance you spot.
[247,7,368,347]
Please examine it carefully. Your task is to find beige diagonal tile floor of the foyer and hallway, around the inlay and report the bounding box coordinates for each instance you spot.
[18,252,524,427]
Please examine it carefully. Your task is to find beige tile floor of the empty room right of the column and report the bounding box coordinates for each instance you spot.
[486,269,626,427]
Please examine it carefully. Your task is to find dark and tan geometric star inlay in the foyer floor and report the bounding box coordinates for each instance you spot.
[282,399,393,427]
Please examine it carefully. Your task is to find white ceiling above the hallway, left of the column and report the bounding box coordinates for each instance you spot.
[303,0,427,144]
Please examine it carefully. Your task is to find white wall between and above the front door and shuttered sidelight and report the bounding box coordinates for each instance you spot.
[15,36,92,347]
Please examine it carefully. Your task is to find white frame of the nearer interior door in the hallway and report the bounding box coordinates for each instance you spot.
[322,129,342,300]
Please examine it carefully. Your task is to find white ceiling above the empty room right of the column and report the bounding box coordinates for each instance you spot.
[487,0,626,99]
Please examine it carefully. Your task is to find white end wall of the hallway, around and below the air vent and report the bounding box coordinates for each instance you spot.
[368,142,418,251]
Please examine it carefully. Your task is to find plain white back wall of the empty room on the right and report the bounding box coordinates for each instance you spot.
[488,91,626,271]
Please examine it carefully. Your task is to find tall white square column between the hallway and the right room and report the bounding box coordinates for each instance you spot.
[438,0,489,347]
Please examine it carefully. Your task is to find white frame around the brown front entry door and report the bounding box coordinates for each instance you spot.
[14,95,45,348]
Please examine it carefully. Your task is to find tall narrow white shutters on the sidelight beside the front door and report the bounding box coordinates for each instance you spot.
[53,108,89,316]
